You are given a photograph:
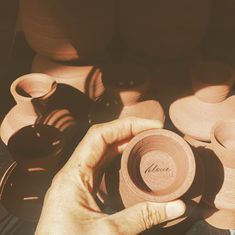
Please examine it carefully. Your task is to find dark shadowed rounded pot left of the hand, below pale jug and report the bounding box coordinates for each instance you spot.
[8,124,64,171]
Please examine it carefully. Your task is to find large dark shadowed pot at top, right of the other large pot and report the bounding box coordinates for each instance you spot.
[118,0,211,60]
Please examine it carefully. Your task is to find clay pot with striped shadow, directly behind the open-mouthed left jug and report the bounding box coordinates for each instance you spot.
[31,55,104,100]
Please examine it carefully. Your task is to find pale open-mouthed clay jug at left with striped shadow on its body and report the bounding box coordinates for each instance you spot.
[0,73,89,144]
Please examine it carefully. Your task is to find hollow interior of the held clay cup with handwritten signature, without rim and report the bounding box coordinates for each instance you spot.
[127,135,189,196]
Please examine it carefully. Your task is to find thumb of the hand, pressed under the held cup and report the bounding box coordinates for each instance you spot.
[109,200,186,234]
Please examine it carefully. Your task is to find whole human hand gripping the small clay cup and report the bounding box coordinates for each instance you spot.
[36,118,185,235]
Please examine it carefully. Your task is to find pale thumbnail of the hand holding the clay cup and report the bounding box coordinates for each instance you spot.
[166,200,186,219]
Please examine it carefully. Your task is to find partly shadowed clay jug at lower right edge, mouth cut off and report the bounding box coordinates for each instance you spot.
[186,120,235,229]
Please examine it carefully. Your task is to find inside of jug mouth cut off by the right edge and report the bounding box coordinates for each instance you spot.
[214,121,235,151]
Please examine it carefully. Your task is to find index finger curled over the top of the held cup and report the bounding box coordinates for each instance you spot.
[65,117,163,169]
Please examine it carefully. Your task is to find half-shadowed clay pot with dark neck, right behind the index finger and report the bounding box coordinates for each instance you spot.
[90,62,165,123]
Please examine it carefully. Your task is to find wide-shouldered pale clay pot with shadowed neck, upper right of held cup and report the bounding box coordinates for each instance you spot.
[169,61,235,141]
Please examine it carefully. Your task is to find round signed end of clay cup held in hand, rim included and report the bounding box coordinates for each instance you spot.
[121,130,195,202]
